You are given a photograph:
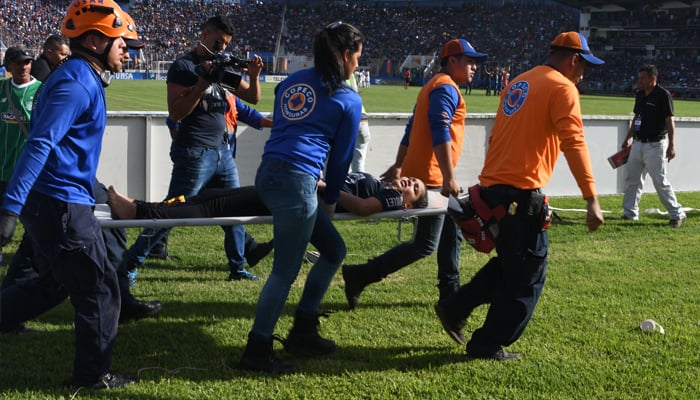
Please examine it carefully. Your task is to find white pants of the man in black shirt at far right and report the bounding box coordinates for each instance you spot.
[622,138,685,219]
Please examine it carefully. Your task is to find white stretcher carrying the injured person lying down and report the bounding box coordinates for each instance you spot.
[95,191,447,228]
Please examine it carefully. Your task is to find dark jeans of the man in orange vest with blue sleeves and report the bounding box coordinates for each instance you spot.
[360,189,462,287]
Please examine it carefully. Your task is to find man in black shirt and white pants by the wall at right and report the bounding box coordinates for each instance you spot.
[622,65,686,228]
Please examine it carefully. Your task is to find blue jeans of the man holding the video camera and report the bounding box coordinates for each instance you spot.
[126,143,252,270]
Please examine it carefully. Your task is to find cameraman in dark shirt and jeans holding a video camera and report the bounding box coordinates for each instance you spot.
[126,16,263,280]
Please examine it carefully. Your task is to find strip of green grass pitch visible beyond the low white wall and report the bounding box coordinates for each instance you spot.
[107,81,700,117]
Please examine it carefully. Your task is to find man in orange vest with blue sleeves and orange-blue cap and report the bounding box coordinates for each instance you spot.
[343,39,487,309]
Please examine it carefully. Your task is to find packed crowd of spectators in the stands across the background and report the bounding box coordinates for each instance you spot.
[0,0,700,93]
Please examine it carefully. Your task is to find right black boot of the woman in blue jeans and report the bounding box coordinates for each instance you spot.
[284,311,336,356]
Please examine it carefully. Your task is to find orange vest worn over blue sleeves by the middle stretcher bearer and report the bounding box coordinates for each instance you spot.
[401,73,467,186]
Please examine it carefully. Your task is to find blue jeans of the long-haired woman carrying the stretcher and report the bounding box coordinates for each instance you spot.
[251,159,347,338]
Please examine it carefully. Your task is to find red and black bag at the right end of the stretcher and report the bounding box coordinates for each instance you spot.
[447,185,506,254]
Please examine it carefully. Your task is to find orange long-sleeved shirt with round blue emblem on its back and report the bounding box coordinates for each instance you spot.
[479,65,596,198]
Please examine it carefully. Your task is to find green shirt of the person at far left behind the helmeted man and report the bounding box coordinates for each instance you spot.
[0,78,41,182]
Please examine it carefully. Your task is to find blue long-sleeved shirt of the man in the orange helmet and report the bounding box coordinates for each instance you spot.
[3,56,107,214]
